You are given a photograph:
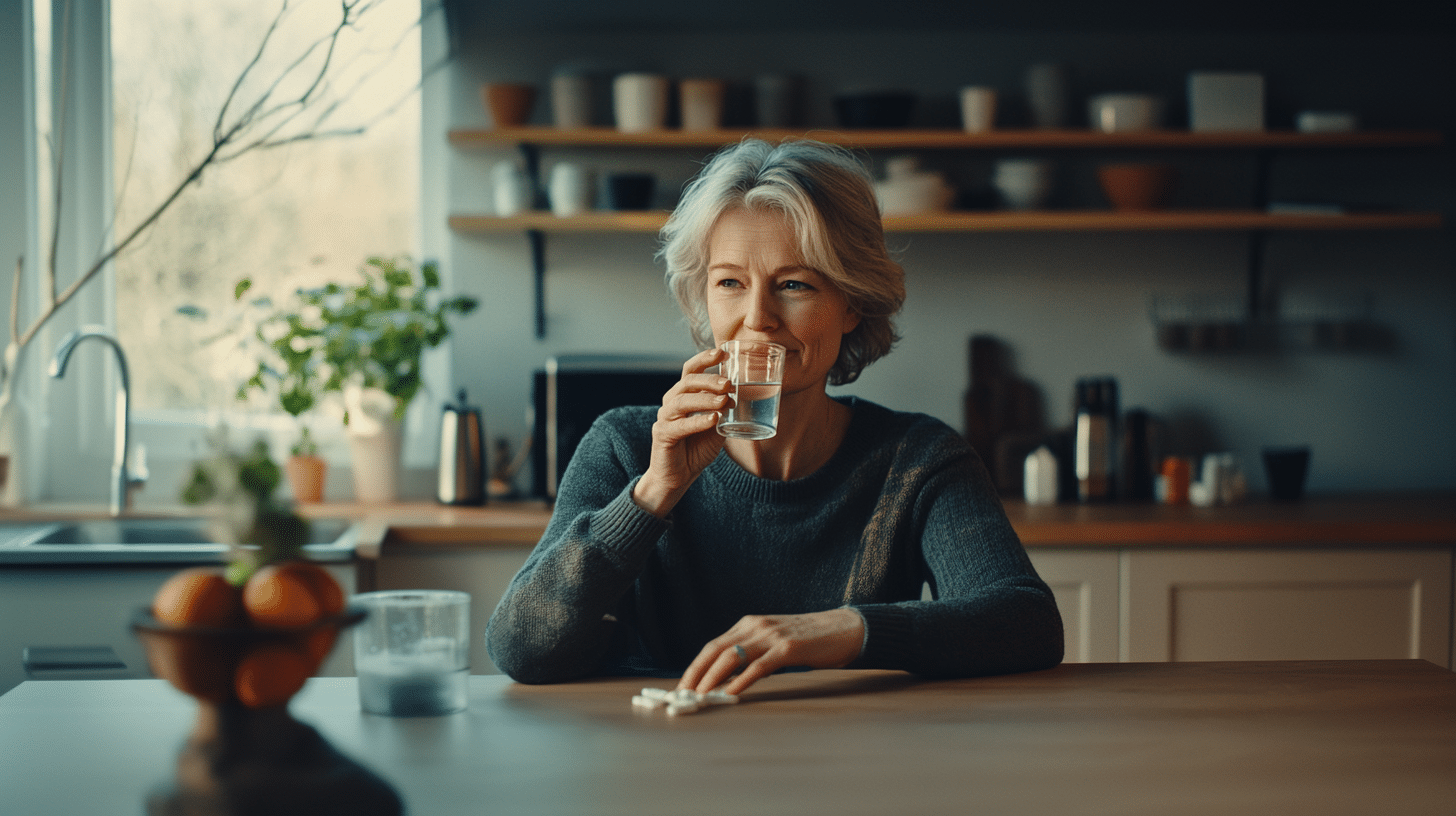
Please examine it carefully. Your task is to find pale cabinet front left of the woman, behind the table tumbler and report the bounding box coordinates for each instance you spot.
[374,544,531,675]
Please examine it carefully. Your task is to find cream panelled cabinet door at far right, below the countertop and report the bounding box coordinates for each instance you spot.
[1123,549,1452,666]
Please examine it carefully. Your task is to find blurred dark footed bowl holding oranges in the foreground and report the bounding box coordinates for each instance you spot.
[132,560,364,708]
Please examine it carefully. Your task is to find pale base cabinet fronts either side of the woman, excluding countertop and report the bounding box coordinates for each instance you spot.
[364,542,1456,675]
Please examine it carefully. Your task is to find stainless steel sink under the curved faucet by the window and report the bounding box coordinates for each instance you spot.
[0,517,354,564]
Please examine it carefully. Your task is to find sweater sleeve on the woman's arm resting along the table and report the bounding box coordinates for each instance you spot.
[855,450,1063,676]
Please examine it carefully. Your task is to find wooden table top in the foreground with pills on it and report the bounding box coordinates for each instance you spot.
[0,660,1456,816]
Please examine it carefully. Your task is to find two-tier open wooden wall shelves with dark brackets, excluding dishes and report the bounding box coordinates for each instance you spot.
[450,127,1441,338]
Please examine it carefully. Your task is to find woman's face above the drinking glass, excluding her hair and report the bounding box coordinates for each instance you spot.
[708,210,859,395]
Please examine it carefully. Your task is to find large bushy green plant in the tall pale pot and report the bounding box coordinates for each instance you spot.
[244,256,478,501]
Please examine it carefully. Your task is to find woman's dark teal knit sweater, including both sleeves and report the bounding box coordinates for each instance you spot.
[486,398,1061,683]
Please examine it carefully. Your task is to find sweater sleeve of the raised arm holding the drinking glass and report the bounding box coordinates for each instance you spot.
[485,410,667,683]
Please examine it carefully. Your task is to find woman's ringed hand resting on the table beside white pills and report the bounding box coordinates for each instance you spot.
[677,608,865,694]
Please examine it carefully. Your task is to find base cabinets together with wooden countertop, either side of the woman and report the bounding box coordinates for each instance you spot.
[333,493,1456,673]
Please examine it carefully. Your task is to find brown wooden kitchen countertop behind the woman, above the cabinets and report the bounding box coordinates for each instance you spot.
[306,493,1456,557]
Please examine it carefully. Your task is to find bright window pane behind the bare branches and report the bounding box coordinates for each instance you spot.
[111,0,421,418]
